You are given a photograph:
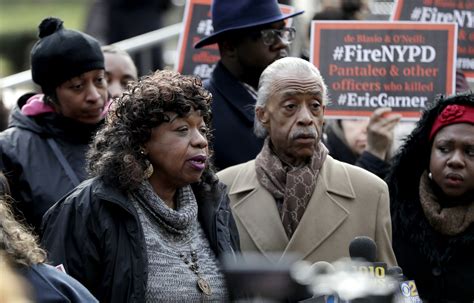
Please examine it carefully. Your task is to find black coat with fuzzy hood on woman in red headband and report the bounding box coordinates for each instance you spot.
[387,94,474,303]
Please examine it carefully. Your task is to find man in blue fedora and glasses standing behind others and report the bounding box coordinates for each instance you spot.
[195,0,303,169]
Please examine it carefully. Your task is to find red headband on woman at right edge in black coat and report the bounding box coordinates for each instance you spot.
[430,104,474,140]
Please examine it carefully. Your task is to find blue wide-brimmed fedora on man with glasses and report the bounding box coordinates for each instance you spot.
[194,0,304,48]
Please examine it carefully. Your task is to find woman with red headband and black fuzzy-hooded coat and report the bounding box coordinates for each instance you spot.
[387,92,474,303]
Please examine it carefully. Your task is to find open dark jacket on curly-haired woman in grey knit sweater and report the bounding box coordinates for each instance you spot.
[42,178,240,302]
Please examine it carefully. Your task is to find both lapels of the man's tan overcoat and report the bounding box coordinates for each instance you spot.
[229,156,355,262]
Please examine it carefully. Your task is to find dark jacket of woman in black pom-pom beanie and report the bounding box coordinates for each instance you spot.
[0,94,98,233]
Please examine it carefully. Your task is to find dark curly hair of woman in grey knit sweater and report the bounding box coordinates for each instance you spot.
[87,70,214,190]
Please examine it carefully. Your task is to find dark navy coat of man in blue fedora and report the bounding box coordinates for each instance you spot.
[204,62,263,169]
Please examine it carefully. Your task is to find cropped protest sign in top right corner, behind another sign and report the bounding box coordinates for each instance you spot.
[391,0,474,80]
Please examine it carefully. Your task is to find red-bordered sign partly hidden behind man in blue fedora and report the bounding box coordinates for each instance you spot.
[175,0,295,79]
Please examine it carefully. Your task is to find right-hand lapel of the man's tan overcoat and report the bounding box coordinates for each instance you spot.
[285,156,355,259]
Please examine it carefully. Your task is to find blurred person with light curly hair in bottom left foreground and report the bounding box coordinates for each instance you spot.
[0,173,97,303]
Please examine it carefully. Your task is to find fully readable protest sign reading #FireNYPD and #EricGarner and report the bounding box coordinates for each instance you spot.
[311,21,456,120]
